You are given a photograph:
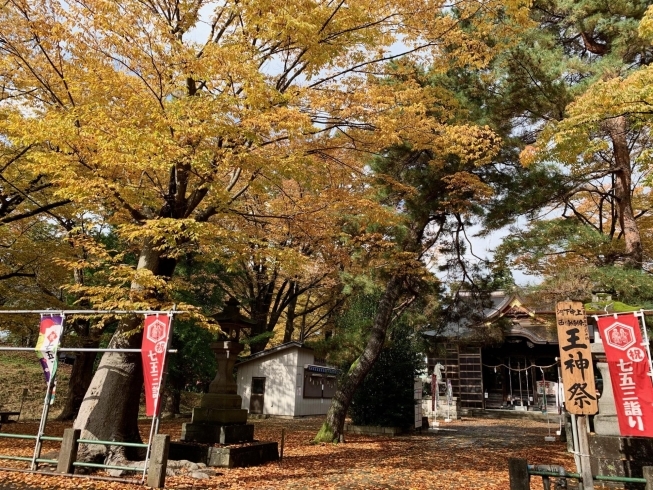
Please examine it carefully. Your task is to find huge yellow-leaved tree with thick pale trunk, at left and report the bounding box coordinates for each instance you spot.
[0,0,525,464]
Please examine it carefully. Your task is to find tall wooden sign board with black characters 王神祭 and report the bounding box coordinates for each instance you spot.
[556,301,599,415]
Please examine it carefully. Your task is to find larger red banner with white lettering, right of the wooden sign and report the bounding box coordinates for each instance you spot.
[597,313,653,437]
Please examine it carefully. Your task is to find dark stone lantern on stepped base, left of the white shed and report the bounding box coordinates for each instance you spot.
[170,298,279,467]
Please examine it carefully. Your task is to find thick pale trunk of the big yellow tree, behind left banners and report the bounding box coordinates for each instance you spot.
[74,240,168,463]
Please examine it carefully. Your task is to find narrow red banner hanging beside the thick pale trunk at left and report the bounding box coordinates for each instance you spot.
[141,315,170,417]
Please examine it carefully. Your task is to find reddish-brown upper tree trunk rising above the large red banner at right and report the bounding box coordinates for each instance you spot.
[603,116,643,269]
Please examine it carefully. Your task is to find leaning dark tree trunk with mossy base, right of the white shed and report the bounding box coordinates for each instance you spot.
[315,274,404,442]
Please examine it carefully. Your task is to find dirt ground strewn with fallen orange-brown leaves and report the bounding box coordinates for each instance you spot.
[0,418,575,490]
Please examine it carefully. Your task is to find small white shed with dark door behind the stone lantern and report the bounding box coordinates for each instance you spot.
[236,342,337,417]
